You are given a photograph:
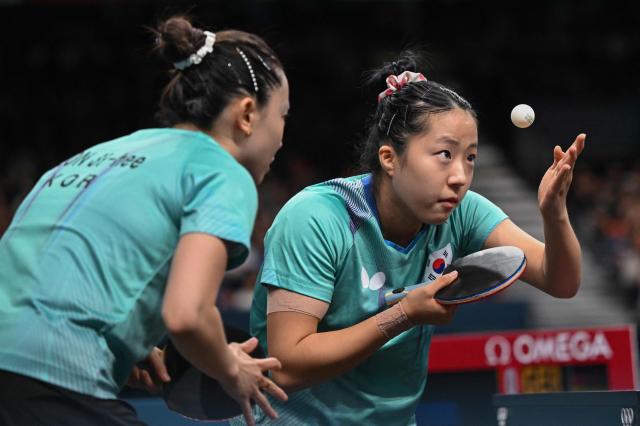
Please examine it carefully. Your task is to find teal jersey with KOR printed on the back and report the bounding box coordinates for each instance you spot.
[0,129,257,398]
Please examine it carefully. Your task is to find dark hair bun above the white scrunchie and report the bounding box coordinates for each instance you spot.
[155,16,205,63]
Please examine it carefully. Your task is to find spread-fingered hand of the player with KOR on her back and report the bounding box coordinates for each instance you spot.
[220,337,287,426]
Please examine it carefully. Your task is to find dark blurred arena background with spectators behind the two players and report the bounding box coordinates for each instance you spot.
[0,0,640,426]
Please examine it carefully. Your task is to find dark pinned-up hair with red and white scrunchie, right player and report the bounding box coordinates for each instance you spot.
[360,50,476,174]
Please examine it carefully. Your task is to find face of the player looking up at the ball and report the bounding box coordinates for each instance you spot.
[391,108,478,224]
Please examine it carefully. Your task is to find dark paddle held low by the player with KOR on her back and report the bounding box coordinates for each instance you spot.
[162,326,264,421]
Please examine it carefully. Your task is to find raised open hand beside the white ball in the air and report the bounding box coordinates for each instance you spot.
[538,133,587,220]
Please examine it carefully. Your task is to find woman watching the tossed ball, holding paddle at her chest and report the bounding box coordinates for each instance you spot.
[245,52,585,425]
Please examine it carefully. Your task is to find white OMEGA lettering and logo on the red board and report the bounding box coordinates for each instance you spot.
[484,331,613,366]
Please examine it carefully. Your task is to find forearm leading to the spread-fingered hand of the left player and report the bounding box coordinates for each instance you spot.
[169,306,237,379]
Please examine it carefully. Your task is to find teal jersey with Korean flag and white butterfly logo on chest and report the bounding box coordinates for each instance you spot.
[245,175,506,426]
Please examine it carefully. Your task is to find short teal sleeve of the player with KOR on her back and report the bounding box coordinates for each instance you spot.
[180,146,258,269]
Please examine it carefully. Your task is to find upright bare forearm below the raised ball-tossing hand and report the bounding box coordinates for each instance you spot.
[542,215,582,298]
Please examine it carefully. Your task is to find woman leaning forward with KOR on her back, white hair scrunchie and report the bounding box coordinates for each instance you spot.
[0,17,289,425]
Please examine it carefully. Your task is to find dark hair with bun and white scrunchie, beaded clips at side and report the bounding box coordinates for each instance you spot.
[152,16,283,129]
